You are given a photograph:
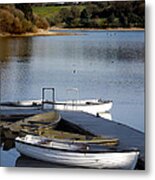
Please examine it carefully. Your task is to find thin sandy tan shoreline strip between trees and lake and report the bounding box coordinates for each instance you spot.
[0,27,145,37]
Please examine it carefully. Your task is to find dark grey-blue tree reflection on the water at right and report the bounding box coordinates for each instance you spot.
[83,40,145,62]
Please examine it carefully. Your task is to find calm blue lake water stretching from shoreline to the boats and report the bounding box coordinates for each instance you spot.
[0,31,145,166]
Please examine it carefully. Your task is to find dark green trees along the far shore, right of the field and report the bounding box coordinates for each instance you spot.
[48,1,145,28]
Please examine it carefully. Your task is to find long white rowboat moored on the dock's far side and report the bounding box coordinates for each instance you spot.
[0,99,113,116]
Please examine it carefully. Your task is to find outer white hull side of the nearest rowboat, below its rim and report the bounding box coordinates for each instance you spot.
[15,140,139,169]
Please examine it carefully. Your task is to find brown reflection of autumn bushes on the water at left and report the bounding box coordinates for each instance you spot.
[0,38,32,62]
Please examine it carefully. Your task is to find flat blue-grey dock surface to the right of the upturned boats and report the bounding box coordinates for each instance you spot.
[61,111,145,166]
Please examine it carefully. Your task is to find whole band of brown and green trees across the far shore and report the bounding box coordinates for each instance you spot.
[0,0,145,34]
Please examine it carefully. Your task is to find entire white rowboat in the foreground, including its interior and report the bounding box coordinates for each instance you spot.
[15,135,139,169]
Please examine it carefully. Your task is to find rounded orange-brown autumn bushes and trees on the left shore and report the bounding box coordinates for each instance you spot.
[0,4,49,34]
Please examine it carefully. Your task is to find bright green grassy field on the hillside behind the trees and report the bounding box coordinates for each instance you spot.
[32,5,84,18]
